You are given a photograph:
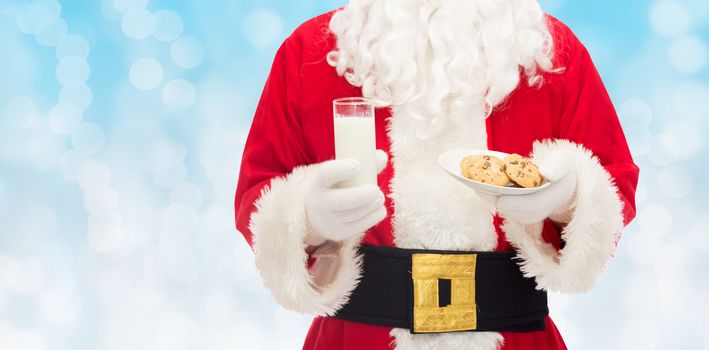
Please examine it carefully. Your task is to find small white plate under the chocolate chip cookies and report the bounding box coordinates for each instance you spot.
[438,149,550,196]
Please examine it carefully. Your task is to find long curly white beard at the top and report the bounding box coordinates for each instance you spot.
[328,0,553,139]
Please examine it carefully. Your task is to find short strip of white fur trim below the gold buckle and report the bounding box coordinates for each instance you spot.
[390,328,504,350]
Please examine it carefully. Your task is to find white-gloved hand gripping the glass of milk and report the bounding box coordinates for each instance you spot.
[305,150,388,246]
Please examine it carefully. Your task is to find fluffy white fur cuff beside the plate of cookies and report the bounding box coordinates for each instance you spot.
[503,140,624,293]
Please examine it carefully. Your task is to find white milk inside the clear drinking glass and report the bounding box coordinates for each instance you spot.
[335,116,377,188]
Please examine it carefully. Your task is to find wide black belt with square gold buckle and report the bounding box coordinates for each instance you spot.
[335,246,549,333]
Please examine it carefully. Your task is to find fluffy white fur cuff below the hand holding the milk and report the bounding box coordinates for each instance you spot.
[249,165,361,316]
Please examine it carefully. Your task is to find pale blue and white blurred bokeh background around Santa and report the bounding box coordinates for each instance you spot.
[0,0,709,350]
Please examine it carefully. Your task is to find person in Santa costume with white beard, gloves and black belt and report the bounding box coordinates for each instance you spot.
[235,0,639,350]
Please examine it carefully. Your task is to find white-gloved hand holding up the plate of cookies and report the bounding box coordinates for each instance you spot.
[479,152,576,224]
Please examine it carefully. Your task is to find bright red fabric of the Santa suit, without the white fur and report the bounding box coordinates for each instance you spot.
[235,13,638,350]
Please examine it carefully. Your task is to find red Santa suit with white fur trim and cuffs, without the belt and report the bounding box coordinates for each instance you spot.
[235,9,639,350]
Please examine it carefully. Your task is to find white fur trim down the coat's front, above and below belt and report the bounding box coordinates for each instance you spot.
[389,95,502,344]
